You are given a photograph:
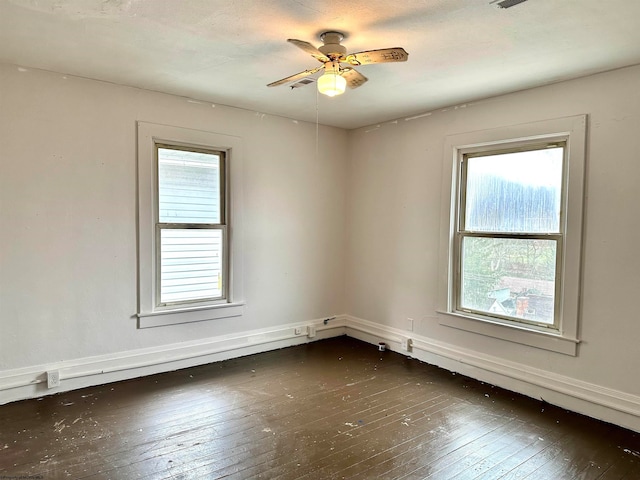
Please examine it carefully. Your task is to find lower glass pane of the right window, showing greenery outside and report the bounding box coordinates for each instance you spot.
[460,237,557,325]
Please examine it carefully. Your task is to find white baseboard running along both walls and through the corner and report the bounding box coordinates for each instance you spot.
[0,315,640,432]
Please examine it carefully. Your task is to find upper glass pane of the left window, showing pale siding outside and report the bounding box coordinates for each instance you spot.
[158,148,221,223]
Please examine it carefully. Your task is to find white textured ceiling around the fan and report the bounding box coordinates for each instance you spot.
[0,0,640,128]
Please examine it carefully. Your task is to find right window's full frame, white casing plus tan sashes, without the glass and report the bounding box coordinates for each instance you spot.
[438,115,587,356]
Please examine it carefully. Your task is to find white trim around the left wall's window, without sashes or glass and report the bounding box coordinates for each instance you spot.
[137,122,244,328]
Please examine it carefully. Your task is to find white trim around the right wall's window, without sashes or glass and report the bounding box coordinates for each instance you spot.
[438,115,587,356]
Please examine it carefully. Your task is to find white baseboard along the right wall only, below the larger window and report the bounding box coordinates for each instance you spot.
[346,316,640,432]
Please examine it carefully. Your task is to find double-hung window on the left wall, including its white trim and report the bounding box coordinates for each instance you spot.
[137,122,243,328]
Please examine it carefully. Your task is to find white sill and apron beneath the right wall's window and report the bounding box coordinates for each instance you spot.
[438,311,580,357]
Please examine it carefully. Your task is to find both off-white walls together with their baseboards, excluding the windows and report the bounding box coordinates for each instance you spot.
[0,60,640,431]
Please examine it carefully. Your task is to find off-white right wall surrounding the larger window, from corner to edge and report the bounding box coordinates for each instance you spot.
[347,63,640,428]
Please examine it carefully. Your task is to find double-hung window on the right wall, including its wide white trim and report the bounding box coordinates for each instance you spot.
[439,116,586,355]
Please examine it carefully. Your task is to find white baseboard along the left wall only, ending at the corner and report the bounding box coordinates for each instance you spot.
[0,316,345,405]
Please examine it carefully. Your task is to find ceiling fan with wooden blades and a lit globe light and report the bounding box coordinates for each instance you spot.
[267,32,409,97]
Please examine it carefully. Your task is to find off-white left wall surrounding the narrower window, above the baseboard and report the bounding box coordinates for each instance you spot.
[0,65,347,372]
